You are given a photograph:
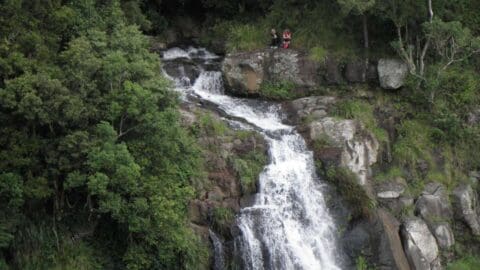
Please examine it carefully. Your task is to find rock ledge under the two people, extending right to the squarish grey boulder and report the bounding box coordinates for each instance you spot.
[222,49,392,96]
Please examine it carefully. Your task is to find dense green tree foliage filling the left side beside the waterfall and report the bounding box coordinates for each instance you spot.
[0,0,205,269]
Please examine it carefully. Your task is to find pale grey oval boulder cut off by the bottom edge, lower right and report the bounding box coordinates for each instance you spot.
[401,217,441,270]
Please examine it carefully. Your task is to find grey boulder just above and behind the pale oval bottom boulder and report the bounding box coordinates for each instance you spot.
[415,182,452,225]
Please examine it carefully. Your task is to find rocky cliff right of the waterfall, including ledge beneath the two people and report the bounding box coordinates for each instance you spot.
[222,49,479,269]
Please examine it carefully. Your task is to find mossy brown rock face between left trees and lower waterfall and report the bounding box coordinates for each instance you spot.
[181,105,267,269]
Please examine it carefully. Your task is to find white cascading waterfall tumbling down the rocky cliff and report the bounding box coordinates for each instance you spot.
[164,48,340,270]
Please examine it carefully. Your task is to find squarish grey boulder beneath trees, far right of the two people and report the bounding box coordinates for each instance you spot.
[377,59,408,89]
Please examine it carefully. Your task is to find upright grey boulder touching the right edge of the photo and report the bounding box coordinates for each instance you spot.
[453,184,480,235]
